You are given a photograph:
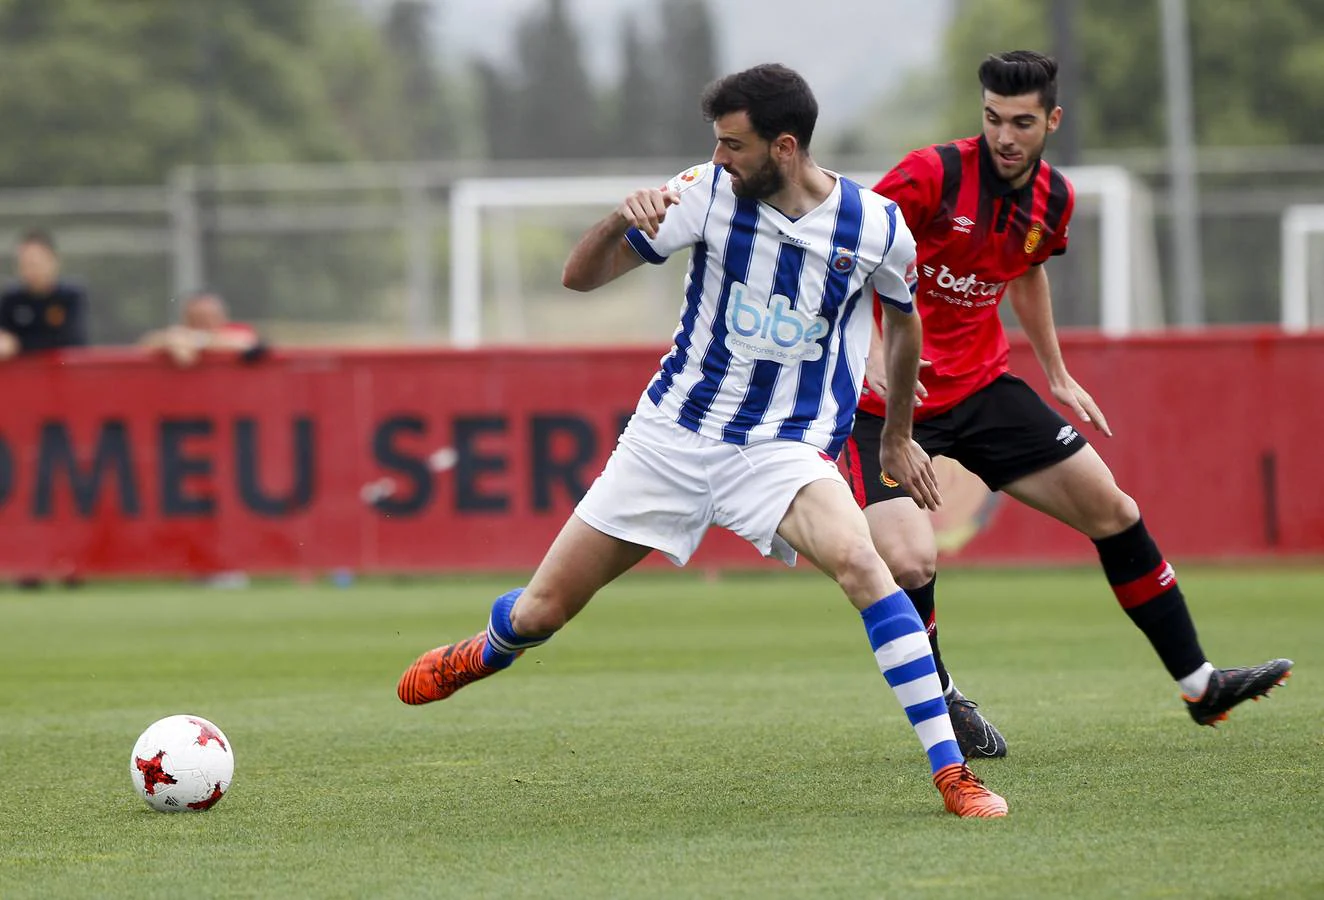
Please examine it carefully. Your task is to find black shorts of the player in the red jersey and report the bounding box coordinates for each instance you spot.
[845,375,1088,507]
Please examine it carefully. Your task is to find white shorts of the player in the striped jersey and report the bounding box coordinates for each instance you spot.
[575,394,845,565]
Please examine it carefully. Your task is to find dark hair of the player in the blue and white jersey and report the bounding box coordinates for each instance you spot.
[700,62,818,150]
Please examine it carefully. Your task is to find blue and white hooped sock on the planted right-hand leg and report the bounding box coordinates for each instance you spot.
[859,589,965,772]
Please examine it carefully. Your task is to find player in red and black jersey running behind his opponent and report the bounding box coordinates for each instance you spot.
[845,50,1292,757]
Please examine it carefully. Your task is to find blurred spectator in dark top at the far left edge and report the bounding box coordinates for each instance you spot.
[0,232,87,360]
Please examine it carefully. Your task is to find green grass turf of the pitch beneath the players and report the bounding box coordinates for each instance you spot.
[0,568,1324,900]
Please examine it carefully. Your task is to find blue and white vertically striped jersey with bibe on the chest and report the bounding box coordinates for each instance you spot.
[625,163,915,458]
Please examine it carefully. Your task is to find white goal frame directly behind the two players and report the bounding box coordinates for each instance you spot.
[450,165,1162,347]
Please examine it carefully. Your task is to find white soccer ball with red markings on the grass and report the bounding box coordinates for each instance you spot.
[128,716,234,813]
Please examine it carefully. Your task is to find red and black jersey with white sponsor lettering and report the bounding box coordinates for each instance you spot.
[859,138,1075,418]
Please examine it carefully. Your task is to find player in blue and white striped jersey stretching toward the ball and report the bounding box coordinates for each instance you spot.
[397,65,1006,817]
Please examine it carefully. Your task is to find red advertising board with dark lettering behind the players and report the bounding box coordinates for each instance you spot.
[0,331,1324,576]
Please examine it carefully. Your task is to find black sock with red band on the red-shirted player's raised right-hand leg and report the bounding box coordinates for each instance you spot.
[1094,519,1205,680]
